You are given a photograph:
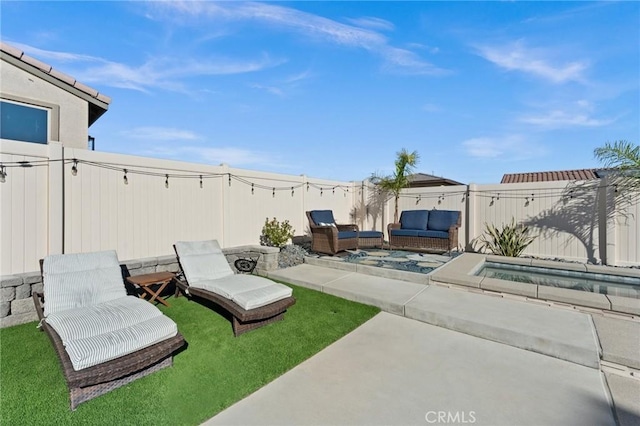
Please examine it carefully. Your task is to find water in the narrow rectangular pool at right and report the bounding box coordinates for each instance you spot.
[476,262,640,299]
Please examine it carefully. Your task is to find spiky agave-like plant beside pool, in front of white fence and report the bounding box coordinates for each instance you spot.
[478,218,536,257]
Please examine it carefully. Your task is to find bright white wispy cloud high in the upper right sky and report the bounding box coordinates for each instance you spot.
[477,41,588,84]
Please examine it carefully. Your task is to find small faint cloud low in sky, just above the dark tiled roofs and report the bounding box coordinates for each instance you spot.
[462,135,544,160]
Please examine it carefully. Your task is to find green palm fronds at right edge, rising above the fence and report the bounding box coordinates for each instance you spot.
[593,140,640,191]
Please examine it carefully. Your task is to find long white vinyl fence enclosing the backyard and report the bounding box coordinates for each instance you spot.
[0,141,640,275]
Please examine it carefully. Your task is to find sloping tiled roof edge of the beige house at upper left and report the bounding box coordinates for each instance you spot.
[0,42,111,126]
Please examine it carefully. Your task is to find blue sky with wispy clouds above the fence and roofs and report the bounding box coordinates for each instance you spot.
[0,0,640,183]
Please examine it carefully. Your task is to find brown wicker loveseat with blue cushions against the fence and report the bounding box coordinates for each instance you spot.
[387,210,461,252]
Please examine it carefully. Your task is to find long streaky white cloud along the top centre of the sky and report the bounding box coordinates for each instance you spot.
[149,1,446,75]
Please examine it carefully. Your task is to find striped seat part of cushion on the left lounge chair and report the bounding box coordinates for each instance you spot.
[46,296,178,370]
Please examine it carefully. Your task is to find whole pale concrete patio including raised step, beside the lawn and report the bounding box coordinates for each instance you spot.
[206,259,640,425]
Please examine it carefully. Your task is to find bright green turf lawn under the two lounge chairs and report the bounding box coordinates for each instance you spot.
[0,286,379,425]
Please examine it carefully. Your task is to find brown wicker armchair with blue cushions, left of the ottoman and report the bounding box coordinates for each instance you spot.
[307,210,359,254]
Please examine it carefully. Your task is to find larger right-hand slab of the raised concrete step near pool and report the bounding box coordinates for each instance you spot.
[405,285,600,368]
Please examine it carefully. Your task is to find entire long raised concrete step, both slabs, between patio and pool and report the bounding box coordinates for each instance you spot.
[268,262,601,368]
